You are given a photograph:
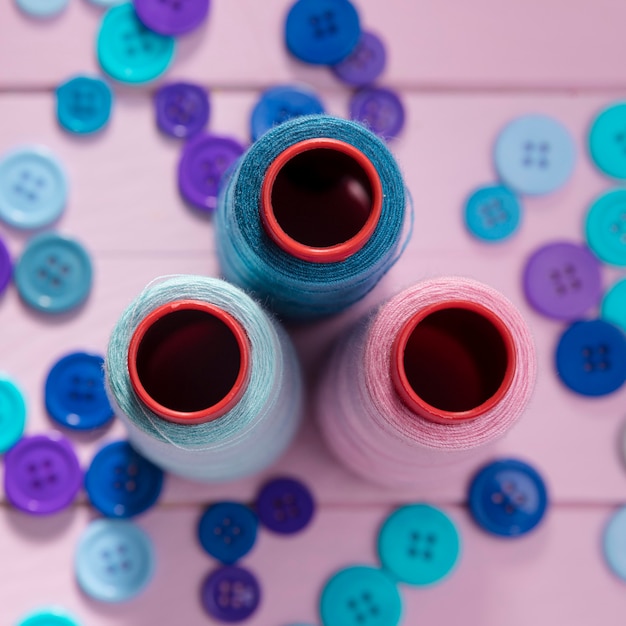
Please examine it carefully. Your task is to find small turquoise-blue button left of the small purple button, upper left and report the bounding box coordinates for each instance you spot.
[56,76,113,135]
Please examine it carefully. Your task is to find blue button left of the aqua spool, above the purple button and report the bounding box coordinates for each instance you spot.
[45,352,113,430]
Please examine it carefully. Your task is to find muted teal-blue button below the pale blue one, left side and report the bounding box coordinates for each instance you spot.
[14,233,92,313]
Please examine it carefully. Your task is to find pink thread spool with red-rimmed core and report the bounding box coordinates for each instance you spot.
[317,278,536,486]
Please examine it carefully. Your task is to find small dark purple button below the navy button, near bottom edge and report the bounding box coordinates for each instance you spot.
[200,566,261,622]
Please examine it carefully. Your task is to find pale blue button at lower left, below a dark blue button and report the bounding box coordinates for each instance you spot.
[74,519,156,602]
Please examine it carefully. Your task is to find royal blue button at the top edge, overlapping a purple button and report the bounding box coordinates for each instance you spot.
[285,0,361,65]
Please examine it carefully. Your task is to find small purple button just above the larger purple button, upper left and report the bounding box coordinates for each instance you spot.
[154,83,210,139]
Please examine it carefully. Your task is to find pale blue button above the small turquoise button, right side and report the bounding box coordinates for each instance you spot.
[494,115,576,195]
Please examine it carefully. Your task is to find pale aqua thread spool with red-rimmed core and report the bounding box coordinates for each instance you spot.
[105,276,302,481]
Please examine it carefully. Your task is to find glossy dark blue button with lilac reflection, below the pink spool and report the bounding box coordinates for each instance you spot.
[469,459,548,537]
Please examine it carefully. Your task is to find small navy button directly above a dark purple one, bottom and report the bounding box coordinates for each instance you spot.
[198,502,259,565]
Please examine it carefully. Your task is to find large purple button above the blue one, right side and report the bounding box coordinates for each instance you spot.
[524,241,602,320]
